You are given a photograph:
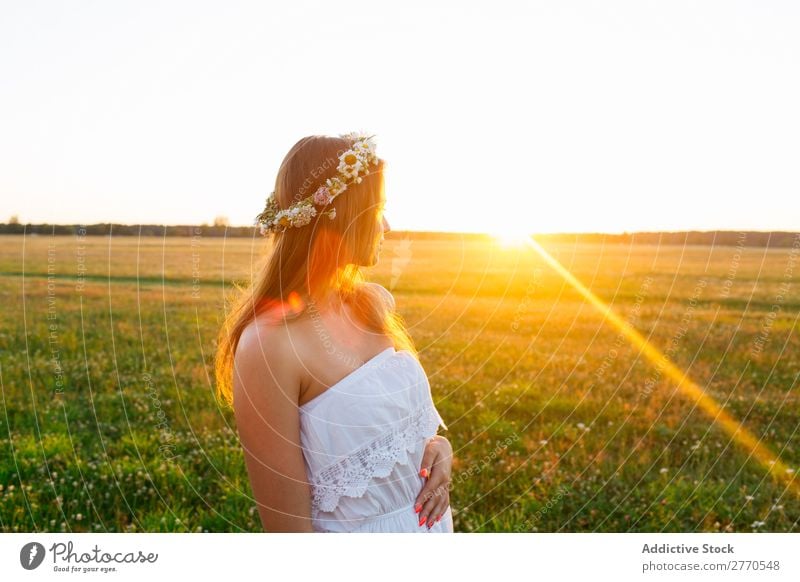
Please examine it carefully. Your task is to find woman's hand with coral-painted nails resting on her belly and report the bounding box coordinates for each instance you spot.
[414,435,453,528]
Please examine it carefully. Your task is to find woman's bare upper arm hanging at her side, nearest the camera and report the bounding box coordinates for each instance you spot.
[233,325,313,532]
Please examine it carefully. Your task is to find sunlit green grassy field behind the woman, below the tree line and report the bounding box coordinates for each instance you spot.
[0,236,800,532]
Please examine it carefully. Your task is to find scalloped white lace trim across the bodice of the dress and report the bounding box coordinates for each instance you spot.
[311,404,440,515]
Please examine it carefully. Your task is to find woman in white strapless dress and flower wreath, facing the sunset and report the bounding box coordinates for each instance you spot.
[216,134,453,532]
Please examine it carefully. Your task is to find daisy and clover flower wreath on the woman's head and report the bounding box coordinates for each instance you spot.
[256,132,378,235]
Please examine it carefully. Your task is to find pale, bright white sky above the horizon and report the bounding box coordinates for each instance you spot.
[0,0,800,233]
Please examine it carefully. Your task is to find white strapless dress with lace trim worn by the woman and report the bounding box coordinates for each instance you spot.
[300,347,453,533]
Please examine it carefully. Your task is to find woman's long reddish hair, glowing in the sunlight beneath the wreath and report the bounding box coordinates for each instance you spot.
[214,135,417,406]
